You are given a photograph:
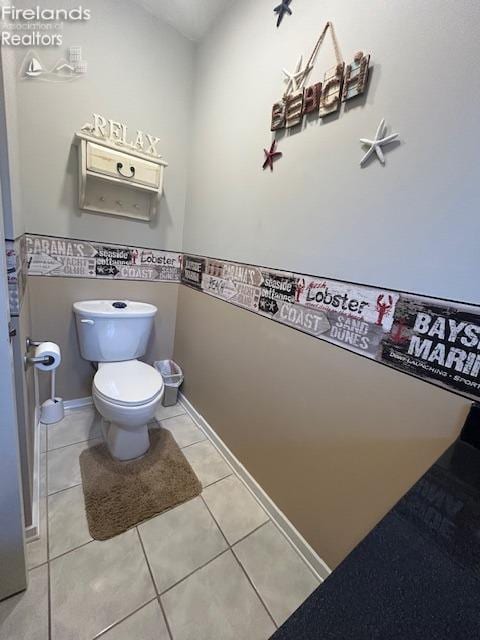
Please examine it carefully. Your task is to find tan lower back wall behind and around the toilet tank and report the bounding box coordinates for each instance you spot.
[29,276,178,400]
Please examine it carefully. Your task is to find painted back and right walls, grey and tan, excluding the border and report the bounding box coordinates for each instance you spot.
[9,0,480,566]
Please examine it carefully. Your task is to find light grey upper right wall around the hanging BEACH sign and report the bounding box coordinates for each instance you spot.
[184,0,480,302]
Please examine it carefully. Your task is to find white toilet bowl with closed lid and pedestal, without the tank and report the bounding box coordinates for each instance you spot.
[92,360,164,460]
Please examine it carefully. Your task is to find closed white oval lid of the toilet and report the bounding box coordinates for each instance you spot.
[93,360,163,406]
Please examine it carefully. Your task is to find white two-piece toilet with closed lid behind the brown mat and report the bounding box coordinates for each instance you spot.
[73,300,164,460]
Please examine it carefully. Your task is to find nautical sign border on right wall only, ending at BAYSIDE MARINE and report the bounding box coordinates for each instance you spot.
[182,255,480,399]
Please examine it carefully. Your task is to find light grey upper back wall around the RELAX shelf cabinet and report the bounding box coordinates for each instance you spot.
[15,0,194,250]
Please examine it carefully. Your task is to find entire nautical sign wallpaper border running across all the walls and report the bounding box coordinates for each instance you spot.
[6,234,480,400]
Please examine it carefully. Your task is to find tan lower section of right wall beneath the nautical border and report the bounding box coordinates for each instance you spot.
[174,287,469,567]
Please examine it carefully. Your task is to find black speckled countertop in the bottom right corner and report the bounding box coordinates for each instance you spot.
[271,440,480,640]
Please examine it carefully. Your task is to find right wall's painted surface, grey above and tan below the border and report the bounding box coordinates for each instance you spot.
[175,0,480,566]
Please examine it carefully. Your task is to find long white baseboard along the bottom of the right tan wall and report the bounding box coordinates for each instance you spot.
[179,393,331,581]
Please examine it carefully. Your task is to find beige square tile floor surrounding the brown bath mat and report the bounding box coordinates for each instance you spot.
[0,405,318,640]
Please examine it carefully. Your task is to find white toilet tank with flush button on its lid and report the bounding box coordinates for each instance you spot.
[73,300,157,362]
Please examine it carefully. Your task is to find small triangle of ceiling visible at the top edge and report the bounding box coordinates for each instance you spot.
[136,0,233,41]
